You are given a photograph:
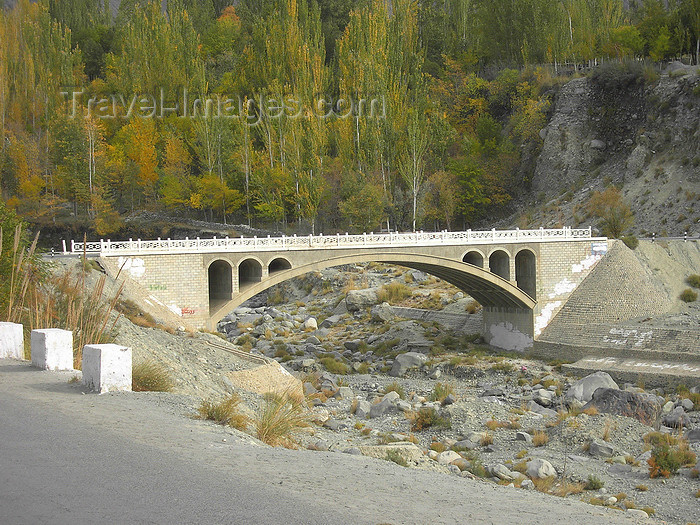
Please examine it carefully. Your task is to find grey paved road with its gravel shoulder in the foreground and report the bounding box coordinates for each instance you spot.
[0,360,648,525]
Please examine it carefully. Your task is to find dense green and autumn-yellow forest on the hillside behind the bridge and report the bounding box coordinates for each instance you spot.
[0,0,700,235]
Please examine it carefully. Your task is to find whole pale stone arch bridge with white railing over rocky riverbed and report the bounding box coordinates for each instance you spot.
[71,228,607,350]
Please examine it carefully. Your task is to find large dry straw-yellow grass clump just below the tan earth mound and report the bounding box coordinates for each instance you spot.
[254,392,309,447]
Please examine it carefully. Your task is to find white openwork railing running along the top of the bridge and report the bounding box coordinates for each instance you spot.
[64,227,592,255]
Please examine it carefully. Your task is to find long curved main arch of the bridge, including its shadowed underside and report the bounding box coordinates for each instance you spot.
[209,252,537,324]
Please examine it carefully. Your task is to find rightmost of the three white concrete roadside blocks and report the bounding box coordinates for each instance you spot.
[83,344,131,394]
